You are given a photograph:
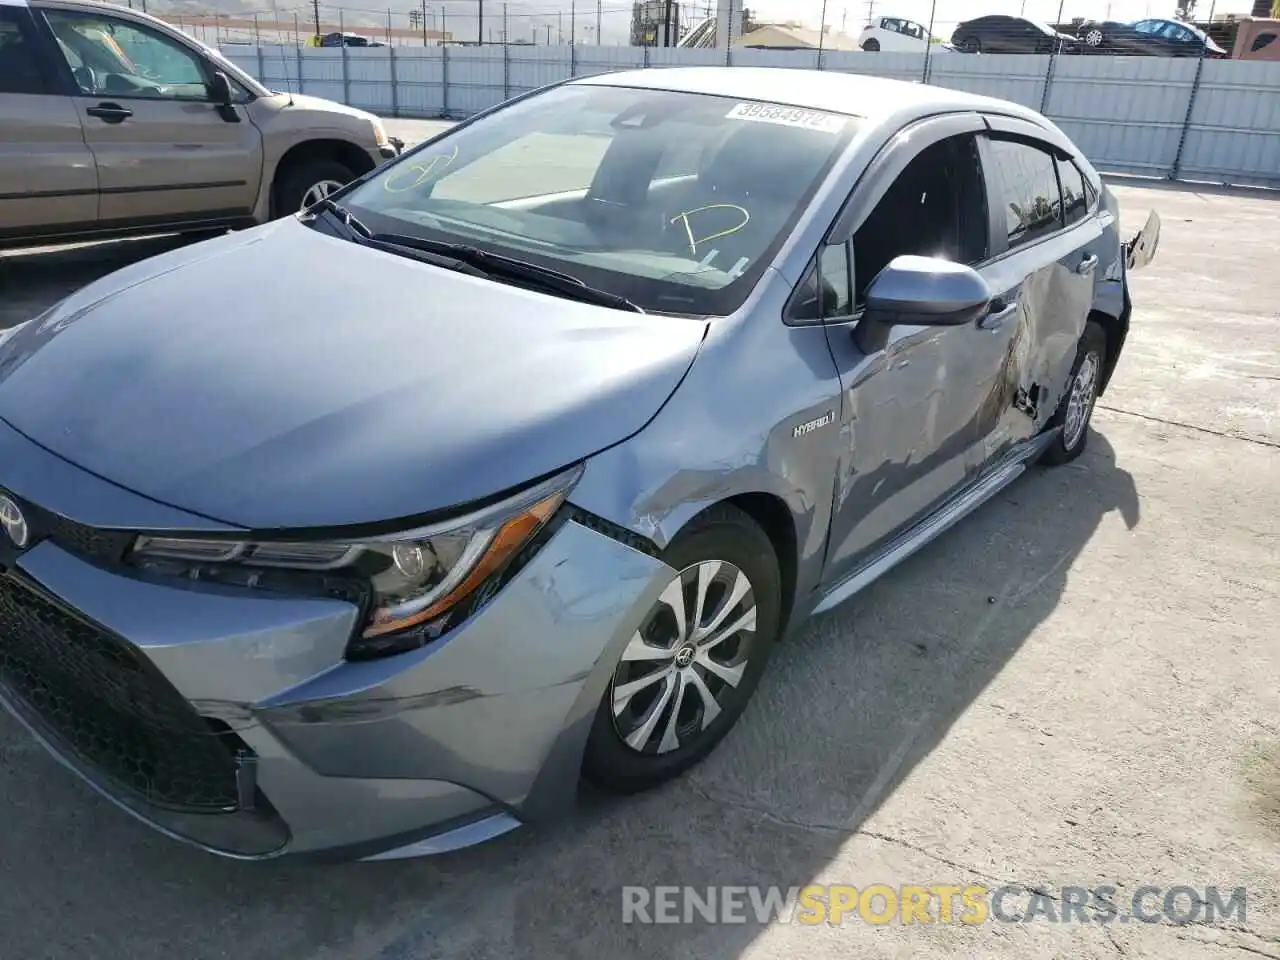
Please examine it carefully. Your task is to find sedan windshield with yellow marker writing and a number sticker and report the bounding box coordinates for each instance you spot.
[342,84,854,316]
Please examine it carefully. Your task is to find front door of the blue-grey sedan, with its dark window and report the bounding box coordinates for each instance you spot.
[827,128,989,579]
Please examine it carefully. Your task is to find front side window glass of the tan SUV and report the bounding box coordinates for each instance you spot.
[45,10,209,100]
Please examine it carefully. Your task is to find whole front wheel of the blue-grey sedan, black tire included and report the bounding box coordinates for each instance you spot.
[582,504,782,794]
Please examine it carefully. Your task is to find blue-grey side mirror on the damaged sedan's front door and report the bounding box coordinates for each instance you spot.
[863,256,993,326]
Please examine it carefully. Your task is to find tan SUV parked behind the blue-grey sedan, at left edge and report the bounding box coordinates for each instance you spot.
[0,0,402,247]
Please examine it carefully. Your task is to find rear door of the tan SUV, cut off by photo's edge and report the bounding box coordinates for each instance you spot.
[0,5,97,239]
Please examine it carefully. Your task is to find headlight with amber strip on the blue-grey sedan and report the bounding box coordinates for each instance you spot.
[129,467,581,657]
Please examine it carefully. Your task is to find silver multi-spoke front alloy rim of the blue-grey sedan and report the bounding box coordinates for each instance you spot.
[609,561,756,755]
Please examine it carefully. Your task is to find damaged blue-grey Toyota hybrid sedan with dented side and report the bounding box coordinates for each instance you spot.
[0,68,1160,859]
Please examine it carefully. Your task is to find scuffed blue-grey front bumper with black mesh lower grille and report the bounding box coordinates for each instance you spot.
[0,425,666,859]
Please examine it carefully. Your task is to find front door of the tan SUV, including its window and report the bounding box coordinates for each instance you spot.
[44,5,262,227]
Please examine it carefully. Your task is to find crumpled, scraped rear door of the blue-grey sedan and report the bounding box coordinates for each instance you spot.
[975,118,1102,466]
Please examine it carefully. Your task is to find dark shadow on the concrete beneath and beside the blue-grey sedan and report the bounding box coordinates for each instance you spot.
[0,433,1139,960]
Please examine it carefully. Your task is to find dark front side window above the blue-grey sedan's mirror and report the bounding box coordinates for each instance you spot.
[854,136,988,305]
